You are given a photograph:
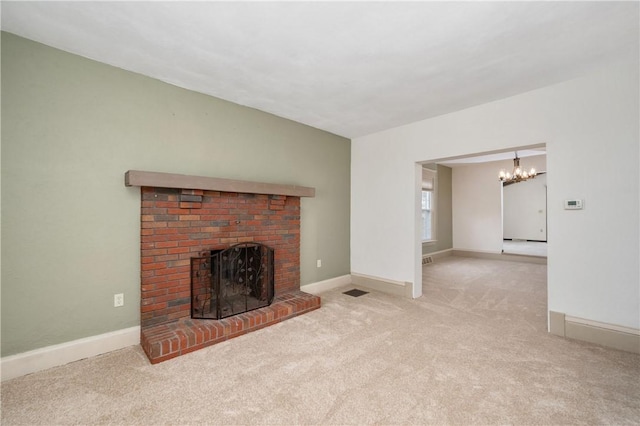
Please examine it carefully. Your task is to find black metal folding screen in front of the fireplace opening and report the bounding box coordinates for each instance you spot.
[191,243,274,319]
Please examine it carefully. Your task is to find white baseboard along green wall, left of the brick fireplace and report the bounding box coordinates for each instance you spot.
[0,326,140,381]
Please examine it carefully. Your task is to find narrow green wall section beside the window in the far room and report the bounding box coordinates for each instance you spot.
[422,164,453,254]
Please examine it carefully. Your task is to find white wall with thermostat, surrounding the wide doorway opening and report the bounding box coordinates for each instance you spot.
[351,63,640,328]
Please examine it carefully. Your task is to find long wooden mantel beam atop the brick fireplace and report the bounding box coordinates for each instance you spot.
[124,170,316,197]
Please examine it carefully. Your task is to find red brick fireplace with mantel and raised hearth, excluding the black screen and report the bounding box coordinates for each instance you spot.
[125,171,320,363]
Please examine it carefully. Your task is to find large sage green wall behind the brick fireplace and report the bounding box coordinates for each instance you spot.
[1,33,351,356]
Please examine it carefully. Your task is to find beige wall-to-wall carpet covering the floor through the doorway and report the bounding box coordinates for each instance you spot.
[2,257,640,425]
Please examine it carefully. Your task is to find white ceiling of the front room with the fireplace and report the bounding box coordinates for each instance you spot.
[1,1,639,138]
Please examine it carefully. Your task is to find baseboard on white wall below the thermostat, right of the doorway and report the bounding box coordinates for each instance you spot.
[549,311,640,354]
